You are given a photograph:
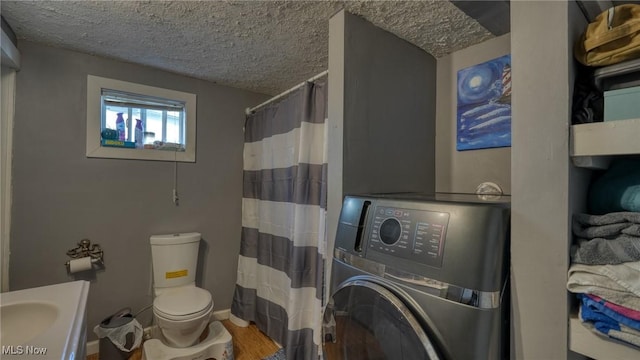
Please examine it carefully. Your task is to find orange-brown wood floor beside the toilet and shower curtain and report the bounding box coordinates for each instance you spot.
[87,320,278,360]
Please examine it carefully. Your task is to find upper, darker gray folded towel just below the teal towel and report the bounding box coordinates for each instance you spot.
[572,212,640,239]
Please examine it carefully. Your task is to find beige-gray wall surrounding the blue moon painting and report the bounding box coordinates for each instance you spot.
[436,34,511,194]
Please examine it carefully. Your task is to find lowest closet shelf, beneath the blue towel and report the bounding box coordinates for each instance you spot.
[569,314,640,360]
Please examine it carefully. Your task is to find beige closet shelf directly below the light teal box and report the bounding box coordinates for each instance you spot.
[570,119,640,169]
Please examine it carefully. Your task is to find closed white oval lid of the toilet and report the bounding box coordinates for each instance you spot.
[153,287,212,317]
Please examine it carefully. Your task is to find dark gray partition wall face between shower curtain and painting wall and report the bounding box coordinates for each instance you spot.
[342,13,436,194]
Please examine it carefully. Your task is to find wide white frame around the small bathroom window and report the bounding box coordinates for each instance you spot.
[86,75,196,162]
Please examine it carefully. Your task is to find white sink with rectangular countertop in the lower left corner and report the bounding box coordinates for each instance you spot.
[0,281,89,359]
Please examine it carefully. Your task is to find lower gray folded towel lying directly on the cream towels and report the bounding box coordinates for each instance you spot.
[571,235,640,265]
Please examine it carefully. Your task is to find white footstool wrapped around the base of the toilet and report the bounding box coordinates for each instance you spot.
[142,321,233,360]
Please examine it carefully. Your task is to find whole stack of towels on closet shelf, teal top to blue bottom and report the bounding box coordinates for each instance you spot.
[567,158,640,347]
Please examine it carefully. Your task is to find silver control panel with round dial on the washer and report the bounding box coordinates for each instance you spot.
[369,206,449,268]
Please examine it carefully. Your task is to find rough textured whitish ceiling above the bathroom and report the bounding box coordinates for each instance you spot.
[0,0,493,95]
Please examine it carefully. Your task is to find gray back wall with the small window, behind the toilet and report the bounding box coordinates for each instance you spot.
[10,41,267,339]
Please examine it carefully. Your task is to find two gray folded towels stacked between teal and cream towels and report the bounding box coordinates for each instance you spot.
[571,212,640,265]
